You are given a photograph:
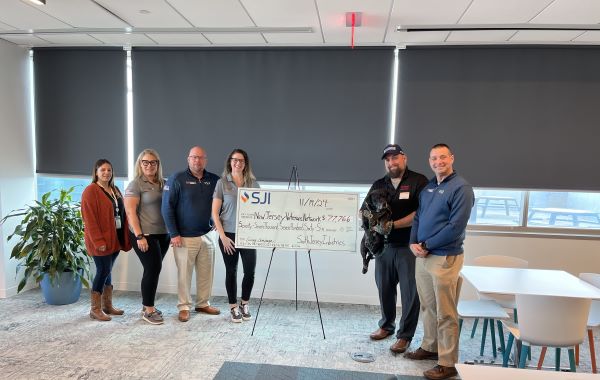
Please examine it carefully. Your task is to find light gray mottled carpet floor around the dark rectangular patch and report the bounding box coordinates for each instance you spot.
[0,290,598,379]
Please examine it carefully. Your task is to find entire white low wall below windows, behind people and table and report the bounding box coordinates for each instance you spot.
[113,234,600,306]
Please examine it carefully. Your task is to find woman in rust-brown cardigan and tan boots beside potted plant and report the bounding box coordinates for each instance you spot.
[81,159,131,321]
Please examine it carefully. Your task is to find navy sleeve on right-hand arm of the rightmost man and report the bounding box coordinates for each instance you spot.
[422,184,475,250]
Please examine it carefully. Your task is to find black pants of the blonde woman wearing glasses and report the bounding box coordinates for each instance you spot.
[129,231,171,306]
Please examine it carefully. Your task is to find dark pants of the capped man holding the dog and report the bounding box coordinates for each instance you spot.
[375,244,421,340]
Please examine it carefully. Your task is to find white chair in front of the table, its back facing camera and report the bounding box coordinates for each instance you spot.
[502,294,591,372]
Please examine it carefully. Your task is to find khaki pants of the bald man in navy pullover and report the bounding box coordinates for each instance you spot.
[173,235,215,310]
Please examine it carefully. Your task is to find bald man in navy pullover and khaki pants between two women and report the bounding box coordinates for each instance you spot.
[162,146,220,322]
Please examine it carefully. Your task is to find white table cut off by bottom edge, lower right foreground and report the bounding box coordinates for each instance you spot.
[456,364,599,380]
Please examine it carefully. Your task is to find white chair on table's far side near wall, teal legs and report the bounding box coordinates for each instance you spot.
[458,255,529,358]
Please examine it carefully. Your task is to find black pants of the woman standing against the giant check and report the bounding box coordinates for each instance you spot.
[219,232,256,304]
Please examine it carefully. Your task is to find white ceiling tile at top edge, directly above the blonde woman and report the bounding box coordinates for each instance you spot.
[96,0,192,28]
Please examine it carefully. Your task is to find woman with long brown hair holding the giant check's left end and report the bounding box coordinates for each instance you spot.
[212,149,259,322]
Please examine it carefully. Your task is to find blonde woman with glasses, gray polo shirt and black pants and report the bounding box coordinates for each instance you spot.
[125,149,170,325]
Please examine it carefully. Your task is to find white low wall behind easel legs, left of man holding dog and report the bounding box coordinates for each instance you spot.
[113,245,378,304]
